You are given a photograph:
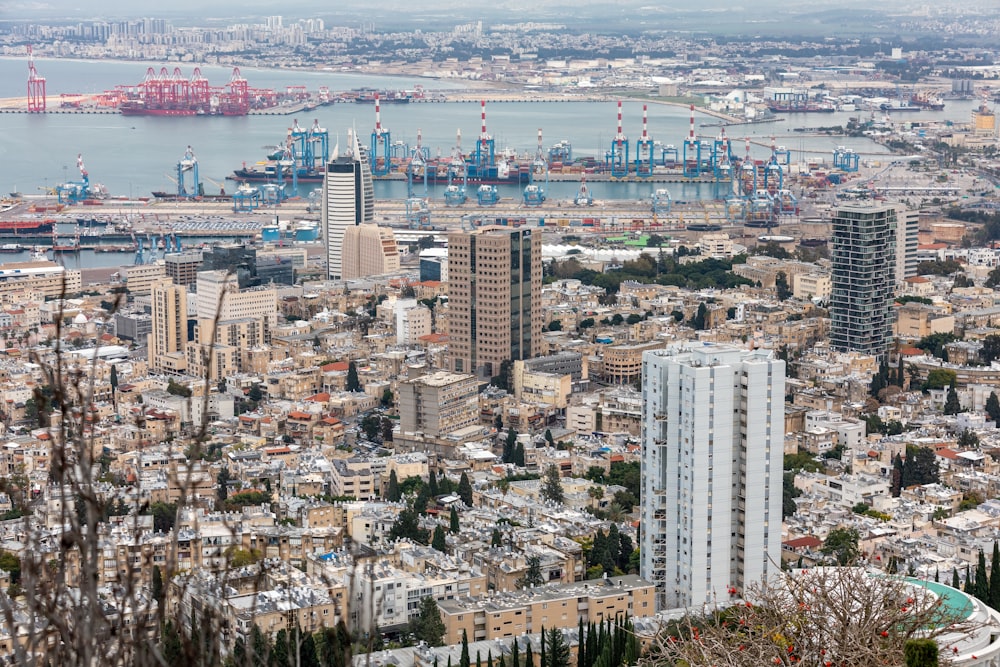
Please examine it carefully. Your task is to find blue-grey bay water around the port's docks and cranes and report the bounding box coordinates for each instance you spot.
[0,58,973,205]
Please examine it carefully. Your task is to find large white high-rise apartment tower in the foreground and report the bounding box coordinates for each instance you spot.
[640,344,785,609]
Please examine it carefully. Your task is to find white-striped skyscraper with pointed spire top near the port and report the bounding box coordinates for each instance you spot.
[322,132,375,280]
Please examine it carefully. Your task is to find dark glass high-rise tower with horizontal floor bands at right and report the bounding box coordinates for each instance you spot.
[830,204,898,356]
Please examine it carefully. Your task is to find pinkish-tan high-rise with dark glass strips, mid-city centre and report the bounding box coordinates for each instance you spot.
[448,227,542,378]
